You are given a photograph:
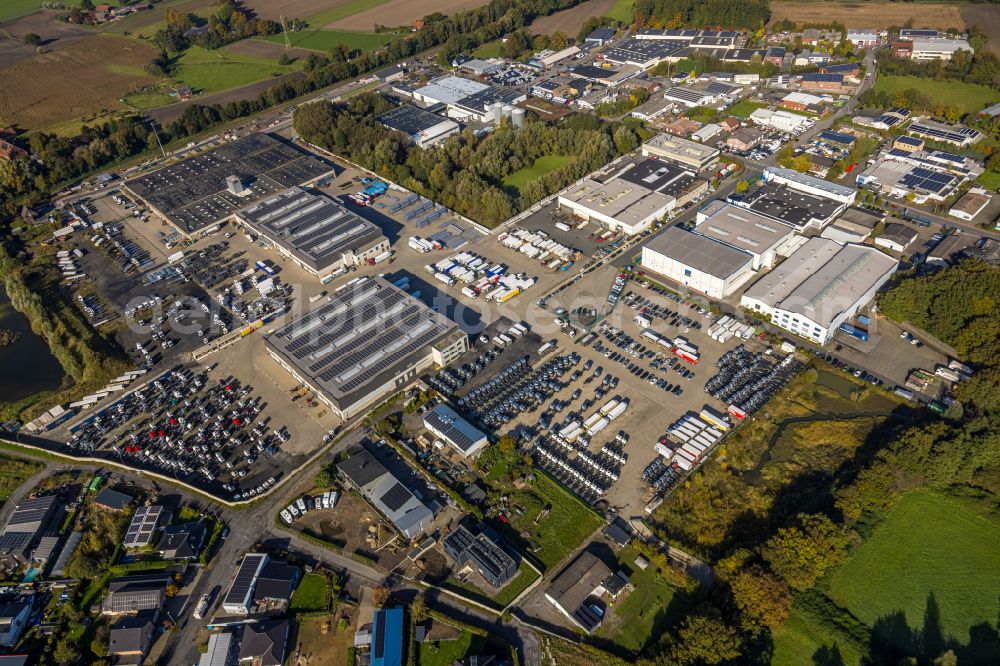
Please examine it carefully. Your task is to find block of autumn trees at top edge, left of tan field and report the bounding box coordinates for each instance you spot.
[634,0,771,30]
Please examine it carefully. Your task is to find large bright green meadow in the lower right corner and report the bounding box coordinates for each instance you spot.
[829,491,1000,644]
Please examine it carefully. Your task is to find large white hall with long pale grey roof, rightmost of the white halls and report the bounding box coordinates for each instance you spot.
[740,237,898,345]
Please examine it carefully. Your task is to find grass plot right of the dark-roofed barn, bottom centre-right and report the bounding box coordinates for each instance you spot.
[597,548,686,653]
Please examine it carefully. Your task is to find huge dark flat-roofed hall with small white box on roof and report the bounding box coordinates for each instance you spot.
[124,133,334,236]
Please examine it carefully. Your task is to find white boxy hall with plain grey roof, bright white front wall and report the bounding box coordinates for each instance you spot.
[641,227,754,300]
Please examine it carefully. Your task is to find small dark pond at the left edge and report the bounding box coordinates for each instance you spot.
[0,285,64,402]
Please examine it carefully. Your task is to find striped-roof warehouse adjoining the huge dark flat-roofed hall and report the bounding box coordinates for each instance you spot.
[236,187,389,280]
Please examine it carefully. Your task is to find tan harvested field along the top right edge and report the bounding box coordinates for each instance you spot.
[771,0,966,30]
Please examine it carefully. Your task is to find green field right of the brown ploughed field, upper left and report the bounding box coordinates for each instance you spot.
[174,46,302,93]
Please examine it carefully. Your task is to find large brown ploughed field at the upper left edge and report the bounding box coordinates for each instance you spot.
[0,35,156,130]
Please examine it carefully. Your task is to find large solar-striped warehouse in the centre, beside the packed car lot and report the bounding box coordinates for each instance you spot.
[267,277,469,419]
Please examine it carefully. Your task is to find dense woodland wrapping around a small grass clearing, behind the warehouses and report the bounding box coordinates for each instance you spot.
[295,93,639,226]
